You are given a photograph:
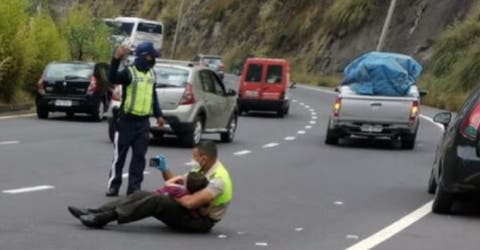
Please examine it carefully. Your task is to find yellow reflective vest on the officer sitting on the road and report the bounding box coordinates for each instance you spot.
[192,161,233,206]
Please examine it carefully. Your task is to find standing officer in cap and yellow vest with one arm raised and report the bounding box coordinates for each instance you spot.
[106,42,165,196]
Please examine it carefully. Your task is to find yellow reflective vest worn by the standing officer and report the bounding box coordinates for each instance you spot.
[123,67,155,116]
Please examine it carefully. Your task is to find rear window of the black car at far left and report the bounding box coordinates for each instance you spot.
[44,63,93,79]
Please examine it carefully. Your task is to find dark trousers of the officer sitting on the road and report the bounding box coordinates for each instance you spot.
[100,191,215,233]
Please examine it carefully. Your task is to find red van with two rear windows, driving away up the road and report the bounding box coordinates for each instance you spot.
[238,58,290,117]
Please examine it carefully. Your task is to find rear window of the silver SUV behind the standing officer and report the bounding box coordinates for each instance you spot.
[154,66,189,87]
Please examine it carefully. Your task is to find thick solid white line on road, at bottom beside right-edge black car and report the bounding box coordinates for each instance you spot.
[346,201,433,250]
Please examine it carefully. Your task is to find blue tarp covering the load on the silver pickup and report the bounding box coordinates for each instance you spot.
[340,52,422,96]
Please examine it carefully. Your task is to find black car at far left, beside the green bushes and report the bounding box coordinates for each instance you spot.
[36,62,111,121]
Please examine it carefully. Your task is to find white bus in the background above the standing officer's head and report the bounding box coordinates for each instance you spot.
[104,17,163,50]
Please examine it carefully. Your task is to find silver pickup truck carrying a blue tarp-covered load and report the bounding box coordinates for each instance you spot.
[325,85,426,149]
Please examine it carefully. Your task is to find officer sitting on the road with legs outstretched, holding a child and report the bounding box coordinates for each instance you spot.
[68,141,232,233]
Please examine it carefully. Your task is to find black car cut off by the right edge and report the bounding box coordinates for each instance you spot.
[428,89,480,213]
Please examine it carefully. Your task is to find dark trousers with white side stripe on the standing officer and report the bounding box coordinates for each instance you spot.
[108,115,150,194]
